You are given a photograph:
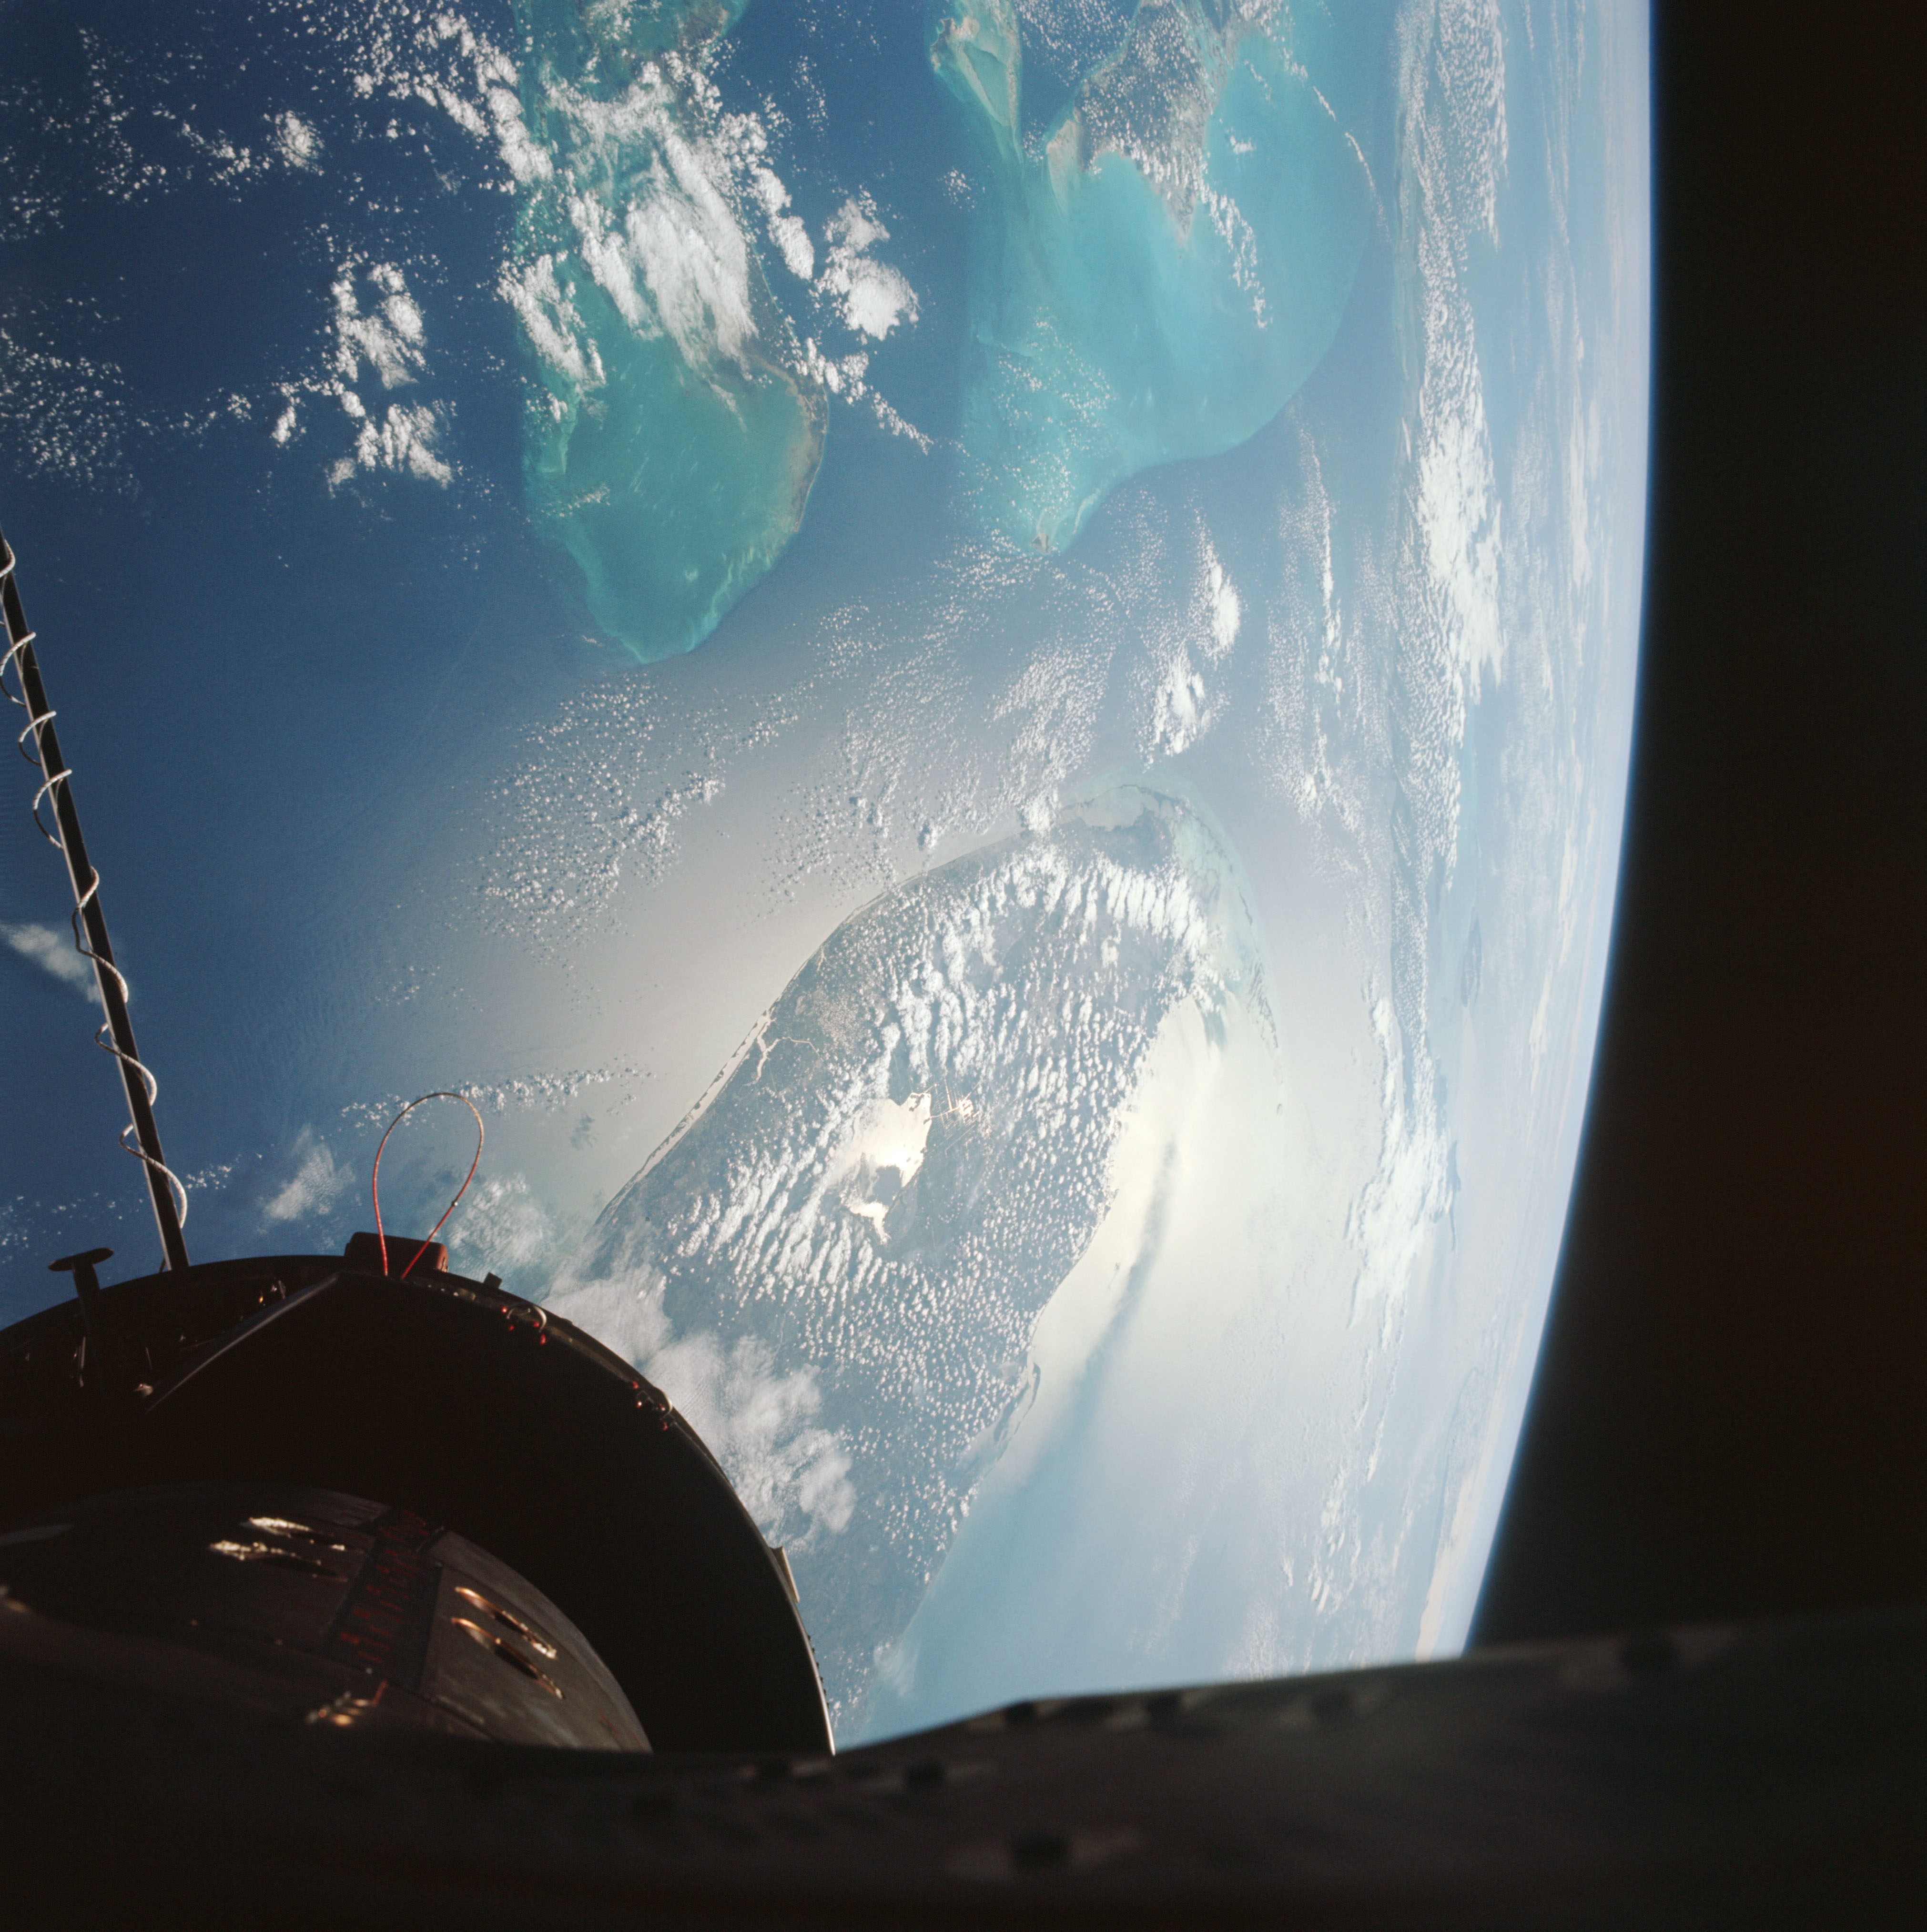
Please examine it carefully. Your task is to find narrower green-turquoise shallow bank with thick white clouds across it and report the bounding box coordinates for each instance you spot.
[502,0,826,659]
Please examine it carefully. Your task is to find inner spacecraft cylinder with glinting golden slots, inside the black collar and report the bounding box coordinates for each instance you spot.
[0,1482,649,1752]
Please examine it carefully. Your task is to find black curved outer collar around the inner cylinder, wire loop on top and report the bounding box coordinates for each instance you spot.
[0,1246,830,1750]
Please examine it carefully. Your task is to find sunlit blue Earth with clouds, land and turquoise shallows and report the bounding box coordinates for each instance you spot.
[0,0,1649,1741]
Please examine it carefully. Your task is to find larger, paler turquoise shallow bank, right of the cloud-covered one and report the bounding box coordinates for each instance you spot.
[931,0,1373,550]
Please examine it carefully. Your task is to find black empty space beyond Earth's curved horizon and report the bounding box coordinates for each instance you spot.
[1473,11,1927,1642]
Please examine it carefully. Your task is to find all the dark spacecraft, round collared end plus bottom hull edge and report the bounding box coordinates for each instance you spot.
[0,1237,1927,1928]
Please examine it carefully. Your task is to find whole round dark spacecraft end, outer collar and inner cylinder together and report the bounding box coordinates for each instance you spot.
[0,1235,830,1750]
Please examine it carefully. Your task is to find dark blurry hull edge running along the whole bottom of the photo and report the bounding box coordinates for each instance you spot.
[0,1613,1927,1932]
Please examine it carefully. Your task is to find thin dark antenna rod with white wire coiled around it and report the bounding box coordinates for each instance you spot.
[0,535,187,1267]
